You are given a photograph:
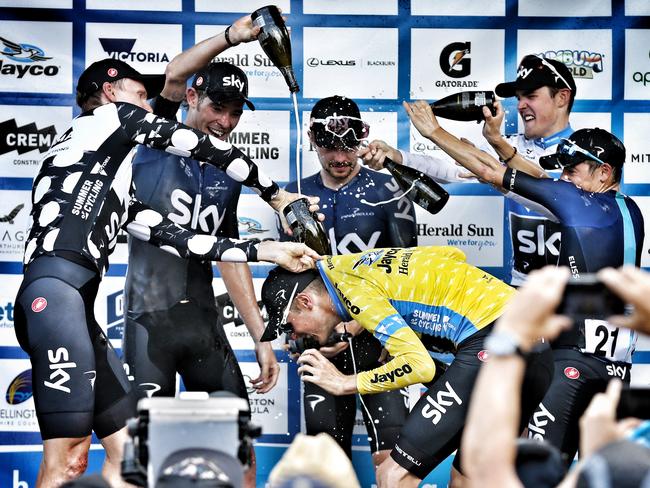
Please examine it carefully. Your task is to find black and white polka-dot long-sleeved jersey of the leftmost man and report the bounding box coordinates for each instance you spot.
[24,102,278,271]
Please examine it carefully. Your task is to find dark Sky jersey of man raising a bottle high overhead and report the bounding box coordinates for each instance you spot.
[125,97,241,313]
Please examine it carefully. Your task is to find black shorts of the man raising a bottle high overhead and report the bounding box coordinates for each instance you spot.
[123,301,248,400]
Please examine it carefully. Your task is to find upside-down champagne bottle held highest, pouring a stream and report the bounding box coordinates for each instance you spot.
[251,5,300,93]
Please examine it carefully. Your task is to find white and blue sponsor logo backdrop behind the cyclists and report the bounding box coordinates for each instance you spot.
[0,0,650,488]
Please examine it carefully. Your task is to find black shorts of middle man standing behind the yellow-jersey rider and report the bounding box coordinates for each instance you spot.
[303,331,409,457]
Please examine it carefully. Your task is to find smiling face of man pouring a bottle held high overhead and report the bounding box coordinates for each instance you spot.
[186,88,244,140]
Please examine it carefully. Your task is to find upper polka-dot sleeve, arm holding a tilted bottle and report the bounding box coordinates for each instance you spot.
[115,102,279,202]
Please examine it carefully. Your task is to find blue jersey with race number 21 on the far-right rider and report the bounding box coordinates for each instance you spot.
[503,168,644,363]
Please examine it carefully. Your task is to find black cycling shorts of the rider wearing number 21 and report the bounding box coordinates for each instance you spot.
[528,348,630,466]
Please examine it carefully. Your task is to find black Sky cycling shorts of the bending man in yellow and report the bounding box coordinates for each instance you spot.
[391,326,553,479]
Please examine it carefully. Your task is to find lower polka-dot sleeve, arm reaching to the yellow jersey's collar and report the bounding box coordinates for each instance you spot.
[124,198,260,262]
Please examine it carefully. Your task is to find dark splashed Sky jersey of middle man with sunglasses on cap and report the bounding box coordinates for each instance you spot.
[283,167,417,254]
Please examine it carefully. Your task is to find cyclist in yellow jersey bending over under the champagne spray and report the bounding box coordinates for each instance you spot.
[262,246,553,487]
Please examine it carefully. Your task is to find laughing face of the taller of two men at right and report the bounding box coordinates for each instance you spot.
[517,86,571,139]
